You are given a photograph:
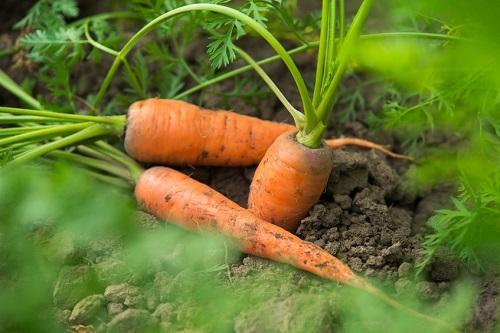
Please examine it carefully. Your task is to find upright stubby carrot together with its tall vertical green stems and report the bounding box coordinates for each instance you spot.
[248,0,373,231]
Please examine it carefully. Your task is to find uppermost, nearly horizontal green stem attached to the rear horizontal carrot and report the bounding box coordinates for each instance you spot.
[0,106,126,126]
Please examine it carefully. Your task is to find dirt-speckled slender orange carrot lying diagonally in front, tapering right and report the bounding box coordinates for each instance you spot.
[135,167,365,286]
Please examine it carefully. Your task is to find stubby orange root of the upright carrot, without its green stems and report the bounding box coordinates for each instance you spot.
[248,132,333,232]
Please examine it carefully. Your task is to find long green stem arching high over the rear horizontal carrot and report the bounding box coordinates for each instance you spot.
[94,4,316,130]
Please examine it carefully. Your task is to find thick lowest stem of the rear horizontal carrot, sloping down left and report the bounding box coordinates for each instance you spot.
[9,124,117,164]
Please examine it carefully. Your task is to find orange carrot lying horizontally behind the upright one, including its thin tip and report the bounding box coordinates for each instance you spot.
[125,99,407,166]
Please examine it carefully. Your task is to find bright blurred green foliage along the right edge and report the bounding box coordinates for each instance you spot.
[356,0,500,269]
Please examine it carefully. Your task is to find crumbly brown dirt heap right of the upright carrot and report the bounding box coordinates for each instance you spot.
[297,150,422,280]
